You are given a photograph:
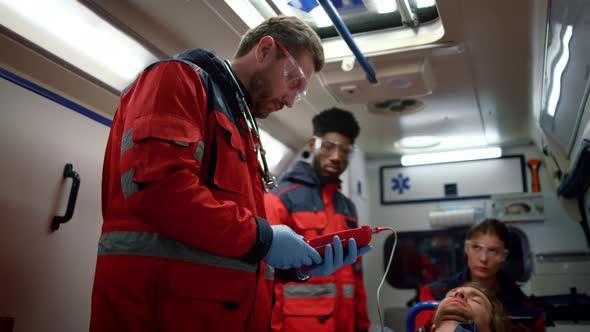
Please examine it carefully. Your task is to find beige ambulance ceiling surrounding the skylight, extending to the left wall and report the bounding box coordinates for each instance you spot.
[0,0,547,158]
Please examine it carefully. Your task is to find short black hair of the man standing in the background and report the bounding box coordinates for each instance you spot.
[312,107,361,143]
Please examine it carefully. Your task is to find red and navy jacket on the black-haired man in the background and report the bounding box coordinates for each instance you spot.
[264,161,371,332]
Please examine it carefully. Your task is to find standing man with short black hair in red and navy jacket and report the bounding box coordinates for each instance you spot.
[265,108,371,332]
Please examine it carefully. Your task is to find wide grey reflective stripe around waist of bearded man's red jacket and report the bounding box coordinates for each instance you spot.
[98,232,258,272]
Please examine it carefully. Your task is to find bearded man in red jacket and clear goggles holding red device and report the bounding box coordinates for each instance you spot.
[90,16,366,332]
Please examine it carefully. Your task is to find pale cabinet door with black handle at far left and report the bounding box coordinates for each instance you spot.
[0,78,109,332]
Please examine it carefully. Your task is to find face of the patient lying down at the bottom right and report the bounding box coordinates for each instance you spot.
[434,287,492,331]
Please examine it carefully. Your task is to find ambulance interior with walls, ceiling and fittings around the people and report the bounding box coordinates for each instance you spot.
[0,0,590,332]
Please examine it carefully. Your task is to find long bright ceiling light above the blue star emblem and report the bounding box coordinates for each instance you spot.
[402,147,502,166]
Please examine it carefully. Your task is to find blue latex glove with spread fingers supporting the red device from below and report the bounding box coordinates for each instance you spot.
[297,236,373,277]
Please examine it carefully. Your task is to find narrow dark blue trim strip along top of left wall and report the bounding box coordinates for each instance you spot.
[0,67,113,127]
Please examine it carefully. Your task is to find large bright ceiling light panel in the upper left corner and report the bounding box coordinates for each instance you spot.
[0,0,158,90]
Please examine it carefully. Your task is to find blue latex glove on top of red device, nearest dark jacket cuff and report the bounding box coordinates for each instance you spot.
[264,225,322,270]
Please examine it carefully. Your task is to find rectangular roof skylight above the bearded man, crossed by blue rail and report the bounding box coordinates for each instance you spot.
[224,0,445,61]
